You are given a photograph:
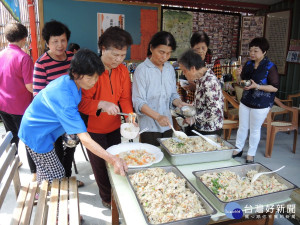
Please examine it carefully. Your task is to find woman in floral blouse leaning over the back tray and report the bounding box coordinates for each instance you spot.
[178,49,224,135]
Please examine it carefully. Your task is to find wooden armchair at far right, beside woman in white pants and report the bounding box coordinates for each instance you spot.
[263,98,298,158]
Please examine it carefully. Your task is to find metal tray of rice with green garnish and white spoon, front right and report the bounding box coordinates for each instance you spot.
[193,163,297,212]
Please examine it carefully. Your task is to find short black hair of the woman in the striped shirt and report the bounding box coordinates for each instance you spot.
[42,20,71,44]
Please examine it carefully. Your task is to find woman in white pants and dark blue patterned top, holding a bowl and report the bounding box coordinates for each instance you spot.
[233,37,279,163]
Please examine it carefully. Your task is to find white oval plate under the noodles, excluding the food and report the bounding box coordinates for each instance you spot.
[106,142,164,168]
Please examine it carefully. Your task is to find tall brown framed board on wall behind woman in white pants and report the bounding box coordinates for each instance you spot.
[265,11,290,75]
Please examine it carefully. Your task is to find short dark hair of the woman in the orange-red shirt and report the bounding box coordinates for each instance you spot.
[98,27,133,51]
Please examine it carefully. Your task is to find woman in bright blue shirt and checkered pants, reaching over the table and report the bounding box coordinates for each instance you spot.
[19,49,127,183]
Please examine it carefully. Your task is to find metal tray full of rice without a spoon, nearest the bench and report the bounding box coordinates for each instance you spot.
[126,166,216,225]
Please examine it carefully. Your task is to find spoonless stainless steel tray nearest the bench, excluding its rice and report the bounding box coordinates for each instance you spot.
[126,166,217,225]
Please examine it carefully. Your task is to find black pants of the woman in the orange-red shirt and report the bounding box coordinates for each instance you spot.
[87,129,121,203]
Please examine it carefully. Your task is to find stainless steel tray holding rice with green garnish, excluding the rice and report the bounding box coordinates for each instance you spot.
[193,163,297,212]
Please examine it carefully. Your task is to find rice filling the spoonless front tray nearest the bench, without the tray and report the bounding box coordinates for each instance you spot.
[129,168,207,224]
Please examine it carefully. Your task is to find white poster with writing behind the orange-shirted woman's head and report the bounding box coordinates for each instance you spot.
[97,13,125,52]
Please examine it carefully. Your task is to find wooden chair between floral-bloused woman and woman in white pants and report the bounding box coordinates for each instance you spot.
[223,91,239,140]
